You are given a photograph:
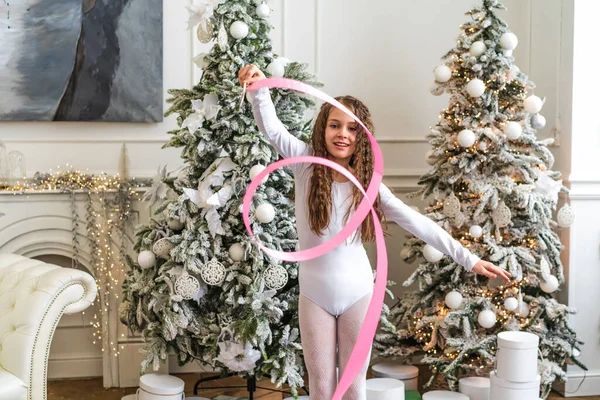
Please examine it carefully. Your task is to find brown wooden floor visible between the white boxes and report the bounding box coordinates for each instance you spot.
[48,374,600,400]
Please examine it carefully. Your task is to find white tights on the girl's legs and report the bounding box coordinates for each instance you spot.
[299,293,372,400]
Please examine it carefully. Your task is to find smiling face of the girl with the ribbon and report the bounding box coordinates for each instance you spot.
[325,108,359,166]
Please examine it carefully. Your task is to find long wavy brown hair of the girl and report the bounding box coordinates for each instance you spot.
[308,96,385,242]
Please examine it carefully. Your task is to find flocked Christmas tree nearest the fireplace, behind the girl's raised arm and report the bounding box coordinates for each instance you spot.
[121,0,315,391]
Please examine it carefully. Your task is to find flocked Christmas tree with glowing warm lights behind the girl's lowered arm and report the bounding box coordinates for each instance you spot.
[375,0,584,397]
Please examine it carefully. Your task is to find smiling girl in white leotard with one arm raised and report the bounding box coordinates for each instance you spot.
[238,65,509,400]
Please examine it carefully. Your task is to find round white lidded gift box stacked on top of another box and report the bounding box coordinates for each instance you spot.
[496,331,540,382]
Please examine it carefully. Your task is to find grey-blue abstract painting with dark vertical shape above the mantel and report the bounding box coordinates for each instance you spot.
[0,0,163,122]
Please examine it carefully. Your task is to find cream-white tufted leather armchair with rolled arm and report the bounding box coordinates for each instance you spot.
[0,253,97,400]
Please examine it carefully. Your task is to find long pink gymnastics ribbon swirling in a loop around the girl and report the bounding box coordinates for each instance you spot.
[242,78,388,400]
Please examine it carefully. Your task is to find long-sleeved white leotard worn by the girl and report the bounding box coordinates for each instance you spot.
[250,88,479,316]
